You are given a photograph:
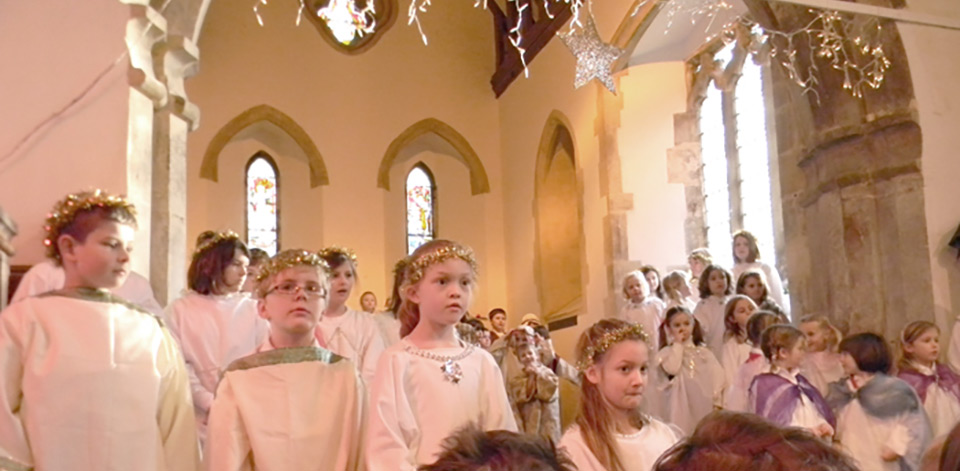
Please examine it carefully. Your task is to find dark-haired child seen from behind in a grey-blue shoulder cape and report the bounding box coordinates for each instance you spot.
[827,333,930,471]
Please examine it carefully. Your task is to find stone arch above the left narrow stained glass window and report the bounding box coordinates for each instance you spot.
[200,105,330,188]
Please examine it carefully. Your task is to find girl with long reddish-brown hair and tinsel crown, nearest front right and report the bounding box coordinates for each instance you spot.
[560,319,681,471]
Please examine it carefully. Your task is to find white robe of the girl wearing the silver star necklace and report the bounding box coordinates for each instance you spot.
[365,340,517,471]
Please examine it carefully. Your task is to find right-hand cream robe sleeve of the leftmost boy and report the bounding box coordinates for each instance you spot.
[157,329,200,471]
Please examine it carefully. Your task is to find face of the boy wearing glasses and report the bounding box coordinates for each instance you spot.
[257,267,326,335]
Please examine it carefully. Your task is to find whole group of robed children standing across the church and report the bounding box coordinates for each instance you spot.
[0,191,960,471]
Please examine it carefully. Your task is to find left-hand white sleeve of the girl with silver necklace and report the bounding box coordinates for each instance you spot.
[365,354,416,471]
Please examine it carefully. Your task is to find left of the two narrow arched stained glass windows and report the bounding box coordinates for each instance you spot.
[247,153,280,256]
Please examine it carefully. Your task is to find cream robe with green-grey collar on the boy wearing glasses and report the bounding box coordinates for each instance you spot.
[204,339,366,471]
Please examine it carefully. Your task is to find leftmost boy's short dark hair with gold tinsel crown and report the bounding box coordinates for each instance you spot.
[43,190,137,265]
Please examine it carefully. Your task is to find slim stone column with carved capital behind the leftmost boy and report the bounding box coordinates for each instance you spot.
[150,36,200,304]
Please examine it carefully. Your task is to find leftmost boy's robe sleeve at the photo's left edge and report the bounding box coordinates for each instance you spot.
[0,307,33,469]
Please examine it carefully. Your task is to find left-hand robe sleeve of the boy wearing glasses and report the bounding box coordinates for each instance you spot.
[203,375,253,471]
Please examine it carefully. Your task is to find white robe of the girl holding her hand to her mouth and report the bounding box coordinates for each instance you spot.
[655,341,727,434]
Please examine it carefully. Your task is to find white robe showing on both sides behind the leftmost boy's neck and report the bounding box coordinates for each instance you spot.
[10,260,167,321]
